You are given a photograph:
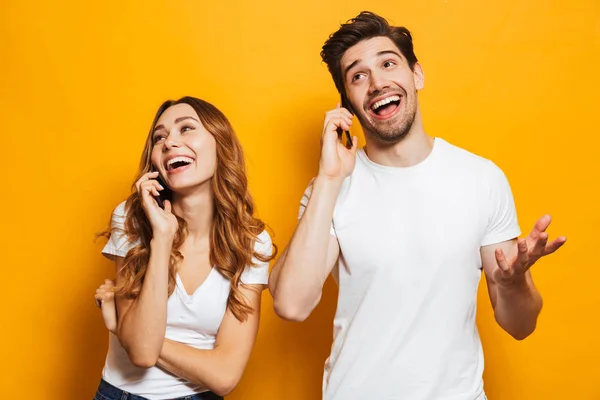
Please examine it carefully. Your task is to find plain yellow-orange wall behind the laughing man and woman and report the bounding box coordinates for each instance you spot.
[0,0,600,400]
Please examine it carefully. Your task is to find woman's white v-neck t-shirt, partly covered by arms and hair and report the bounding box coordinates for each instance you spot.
[102,203,272,400]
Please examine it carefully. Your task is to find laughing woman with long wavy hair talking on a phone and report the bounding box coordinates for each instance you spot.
[96,97,276,400]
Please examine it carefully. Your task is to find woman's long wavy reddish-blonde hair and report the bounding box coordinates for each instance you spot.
[100,97,277,321]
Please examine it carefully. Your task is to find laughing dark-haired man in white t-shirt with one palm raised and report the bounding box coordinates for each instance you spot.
[270,12,566,400]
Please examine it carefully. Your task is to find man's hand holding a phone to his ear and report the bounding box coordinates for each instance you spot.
[319,104,358,183]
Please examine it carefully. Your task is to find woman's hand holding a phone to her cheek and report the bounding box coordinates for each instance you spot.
[135,171,179,240]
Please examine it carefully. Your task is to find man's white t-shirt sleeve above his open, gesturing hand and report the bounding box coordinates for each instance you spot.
[481,161,521,246]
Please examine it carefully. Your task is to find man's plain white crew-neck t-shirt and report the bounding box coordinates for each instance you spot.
[300,138,521,400]
